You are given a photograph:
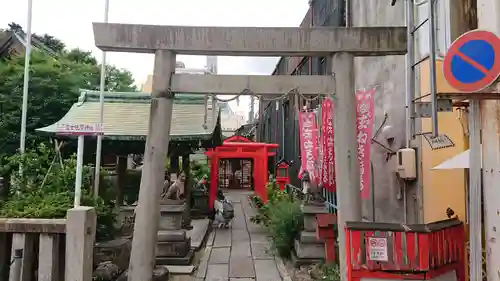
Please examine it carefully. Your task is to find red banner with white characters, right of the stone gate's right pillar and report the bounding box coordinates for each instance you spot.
[356,89,375,199]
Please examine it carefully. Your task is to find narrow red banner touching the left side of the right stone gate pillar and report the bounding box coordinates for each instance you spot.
[321,98,336,191]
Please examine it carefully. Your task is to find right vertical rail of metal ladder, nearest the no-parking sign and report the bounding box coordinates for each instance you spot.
[428,0,439,137]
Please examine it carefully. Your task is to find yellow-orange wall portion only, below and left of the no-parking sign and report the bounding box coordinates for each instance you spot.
[420,60,469,223]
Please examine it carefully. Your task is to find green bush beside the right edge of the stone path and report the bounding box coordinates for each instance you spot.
[251,181,304,258]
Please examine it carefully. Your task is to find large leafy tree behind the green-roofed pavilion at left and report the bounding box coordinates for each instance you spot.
[0,25,137,156]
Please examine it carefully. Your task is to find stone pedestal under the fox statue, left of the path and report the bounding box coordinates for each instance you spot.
[156,201,193,265]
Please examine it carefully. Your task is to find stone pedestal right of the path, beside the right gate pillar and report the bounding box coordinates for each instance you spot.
[293,203,328,266]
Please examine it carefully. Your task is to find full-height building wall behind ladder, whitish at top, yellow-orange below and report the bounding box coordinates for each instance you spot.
[417,0,475,222]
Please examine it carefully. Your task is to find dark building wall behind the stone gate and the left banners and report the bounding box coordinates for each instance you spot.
[257,0,345,188]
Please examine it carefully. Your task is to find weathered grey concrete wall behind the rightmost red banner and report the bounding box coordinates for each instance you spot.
[351,0,417,222]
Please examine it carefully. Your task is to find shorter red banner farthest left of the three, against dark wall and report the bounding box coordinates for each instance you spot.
[299,111,318,182]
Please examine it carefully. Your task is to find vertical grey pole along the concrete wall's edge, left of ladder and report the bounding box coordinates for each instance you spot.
[405,0,415,148]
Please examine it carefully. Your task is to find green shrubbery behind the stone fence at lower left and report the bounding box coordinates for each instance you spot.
[0,145,116,241]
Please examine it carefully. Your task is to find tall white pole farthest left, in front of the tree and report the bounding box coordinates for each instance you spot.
[19,0,33,153]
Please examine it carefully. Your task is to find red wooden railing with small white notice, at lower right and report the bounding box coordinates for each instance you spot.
[346,219,465,281]
